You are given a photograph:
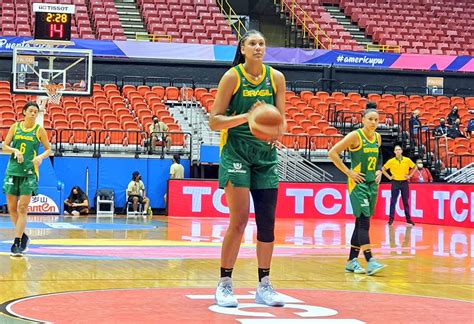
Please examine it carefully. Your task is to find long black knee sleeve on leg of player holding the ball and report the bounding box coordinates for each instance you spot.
[250,189,278,243]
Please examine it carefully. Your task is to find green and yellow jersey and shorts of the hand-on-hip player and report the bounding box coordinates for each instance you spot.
[348,129,380,217]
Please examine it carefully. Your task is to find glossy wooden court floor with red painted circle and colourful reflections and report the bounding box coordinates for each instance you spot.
[0,216,474,323]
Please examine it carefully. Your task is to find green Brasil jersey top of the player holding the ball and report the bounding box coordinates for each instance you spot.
[222,64,276,146]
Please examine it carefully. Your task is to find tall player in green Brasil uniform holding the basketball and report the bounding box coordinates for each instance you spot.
[209,30,286,307]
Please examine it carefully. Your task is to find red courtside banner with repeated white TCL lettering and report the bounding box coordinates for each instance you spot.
[168,180,474,228]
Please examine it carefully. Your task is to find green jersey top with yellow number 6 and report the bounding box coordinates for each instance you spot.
[5,122,40,177]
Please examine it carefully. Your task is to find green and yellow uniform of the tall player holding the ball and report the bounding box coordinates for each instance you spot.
[219,64,278,189]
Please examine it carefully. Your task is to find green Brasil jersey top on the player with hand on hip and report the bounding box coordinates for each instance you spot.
[349,129,380,187]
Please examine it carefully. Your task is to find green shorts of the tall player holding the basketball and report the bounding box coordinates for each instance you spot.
[219,136,278,189]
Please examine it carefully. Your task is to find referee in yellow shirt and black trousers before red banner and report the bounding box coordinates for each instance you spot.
[382,145,416,226]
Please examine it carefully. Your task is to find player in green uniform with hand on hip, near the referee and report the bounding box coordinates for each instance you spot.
[328,109,385,276]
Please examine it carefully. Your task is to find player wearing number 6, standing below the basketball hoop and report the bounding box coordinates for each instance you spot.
[3,101,51,256]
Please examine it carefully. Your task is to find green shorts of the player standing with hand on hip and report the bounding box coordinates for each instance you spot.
[349,181,379,217]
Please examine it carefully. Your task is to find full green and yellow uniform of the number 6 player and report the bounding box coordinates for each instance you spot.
[3,122,40,196]
